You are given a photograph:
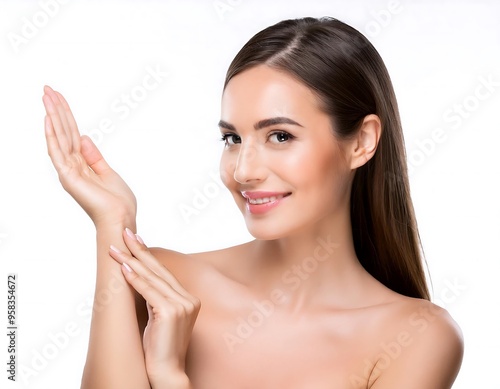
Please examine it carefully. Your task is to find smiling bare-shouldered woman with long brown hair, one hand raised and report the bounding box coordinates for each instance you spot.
[43,18,463,389]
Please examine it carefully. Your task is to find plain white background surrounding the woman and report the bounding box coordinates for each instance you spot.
[0,0,500,389]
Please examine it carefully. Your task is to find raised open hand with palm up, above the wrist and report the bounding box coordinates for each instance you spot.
[42,86,137,227]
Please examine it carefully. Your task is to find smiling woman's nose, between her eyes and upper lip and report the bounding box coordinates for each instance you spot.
[233,143,265,184]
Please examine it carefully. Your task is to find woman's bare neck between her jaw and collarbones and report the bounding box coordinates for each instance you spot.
[249,211,368,310]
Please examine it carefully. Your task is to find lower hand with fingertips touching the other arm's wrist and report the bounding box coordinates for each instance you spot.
[109,229,201,388]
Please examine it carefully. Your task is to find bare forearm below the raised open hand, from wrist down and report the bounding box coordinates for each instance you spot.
[82,222,150,389]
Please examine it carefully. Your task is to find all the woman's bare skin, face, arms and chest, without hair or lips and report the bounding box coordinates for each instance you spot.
[43,65,463,389]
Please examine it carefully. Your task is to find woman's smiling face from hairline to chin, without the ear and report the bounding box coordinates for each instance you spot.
[219,65,351,239]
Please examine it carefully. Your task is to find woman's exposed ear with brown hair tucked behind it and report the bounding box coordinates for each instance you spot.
[350,115,382,170]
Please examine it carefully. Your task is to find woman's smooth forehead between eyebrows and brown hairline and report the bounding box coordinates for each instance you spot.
[221,65,326,122]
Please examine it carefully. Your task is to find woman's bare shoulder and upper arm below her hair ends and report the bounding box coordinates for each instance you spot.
[370,296,464,389]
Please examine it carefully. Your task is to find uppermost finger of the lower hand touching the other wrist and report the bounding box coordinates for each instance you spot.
[123,228,192,298]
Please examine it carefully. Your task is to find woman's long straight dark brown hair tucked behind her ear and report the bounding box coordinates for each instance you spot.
[224,18,429,299]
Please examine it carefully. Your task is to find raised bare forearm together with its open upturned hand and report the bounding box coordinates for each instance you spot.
[43,87,150,389]
